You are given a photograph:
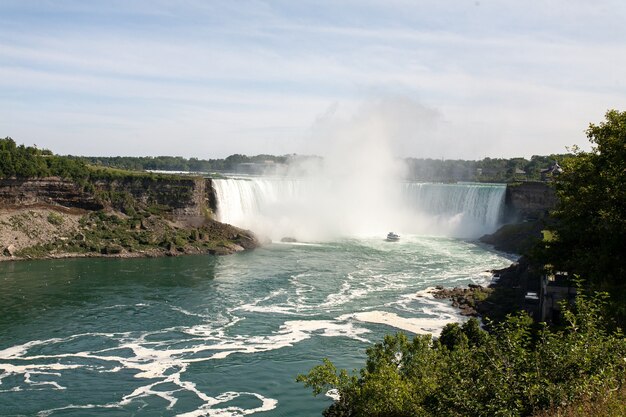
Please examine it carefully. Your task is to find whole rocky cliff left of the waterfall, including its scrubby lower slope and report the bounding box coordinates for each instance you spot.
[0,174,258,260]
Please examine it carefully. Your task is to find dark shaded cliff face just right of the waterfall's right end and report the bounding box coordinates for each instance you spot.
[505,182,558,222]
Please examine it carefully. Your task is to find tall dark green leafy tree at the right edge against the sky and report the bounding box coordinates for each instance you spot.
[539,110,626,325]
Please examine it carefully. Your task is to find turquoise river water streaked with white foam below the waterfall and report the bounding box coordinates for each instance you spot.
[0,236,510,417]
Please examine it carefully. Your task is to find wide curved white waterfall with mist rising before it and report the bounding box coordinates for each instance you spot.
[213,177,506,241]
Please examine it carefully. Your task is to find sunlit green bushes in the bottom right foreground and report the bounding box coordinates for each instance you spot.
[297,293,626,417]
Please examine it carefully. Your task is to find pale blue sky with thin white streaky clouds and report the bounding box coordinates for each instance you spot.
[0,0,626,159]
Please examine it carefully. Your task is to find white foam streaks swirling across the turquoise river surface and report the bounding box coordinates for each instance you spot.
[0,232,512,417]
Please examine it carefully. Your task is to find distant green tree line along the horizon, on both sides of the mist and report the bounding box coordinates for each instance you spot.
[0,137,570,182]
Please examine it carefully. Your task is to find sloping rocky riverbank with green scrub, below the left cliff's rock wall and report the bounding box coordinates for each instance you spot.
[0,204,259,261]
